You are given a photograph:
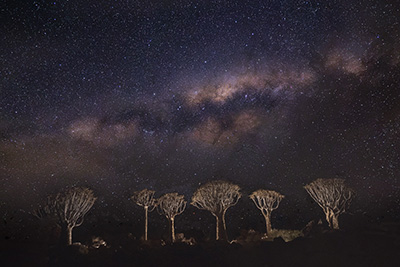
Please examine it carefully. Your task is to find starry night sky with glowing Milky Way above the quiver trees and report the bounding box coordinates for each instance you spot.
[0,0,400,225]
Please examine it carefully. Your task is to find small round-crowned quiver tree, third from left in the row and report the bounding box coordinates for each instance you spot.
[157,193,186,243]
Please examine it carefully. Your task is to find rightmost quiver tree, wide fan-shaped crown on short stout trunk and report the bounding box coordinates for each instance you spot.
[304,179,354,229]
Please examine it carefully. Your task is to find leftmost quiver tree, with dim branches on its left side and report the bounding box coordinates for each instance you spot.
[33,187,96,245]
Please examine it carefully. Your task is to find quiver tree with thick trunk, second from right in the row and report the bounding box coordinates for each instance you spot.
[250,189,285,235]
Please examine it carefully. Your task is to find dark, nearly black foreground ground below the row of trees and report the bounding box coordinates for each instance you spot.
[0,224,400,266]
